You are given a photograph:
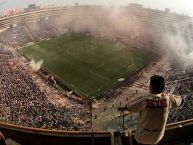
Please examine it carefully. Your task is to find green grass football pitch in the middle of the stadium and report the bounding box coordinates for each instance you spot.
[21,34,154,96]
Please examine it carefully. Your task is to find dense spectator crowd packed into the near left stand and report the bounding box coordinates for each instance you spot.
[0,55,91,130]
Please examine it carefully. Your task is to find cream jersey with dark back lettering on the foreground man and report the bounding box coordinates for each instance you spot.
[127,94,182,144]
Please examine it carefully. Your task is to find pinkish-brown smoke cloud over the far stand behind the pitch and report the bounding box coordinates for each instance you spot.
[54,7,152,49]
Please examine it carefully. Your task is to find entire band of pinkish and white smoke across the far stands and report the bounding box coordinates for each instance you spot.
[27,7,193,67]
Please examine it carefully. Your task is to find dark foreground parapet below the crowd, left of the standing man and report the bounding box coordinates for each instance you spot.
[0,123,114,145]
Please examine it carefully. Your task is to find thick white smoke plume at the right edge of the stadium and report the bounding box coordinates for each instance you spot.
[162,18,193,69]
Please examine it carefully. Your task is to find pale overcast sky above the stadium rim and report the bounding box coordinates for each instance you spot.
[0,0,193,16]
